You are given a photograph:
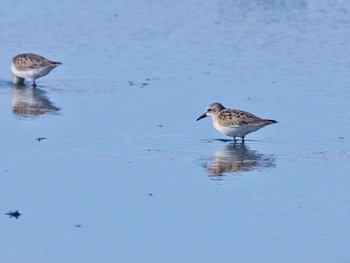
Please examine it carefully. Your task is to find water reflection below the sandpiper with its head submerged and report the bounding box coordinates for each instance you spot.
[12,84,60,117]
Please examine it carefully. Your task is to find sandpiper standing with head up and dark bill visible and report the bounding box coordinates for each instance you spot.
[197,102,277,143]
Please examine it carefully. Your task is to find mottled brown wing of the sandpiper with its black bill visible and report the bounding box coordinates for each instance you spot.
[218,109,264,127]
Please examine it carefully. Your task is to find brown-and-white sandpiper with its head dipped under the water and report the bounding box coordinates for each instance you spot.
[11,53,62,87]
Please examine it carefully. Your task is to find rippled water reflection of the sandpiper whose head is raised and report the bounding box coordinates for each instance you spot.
[204,143,275,176]
